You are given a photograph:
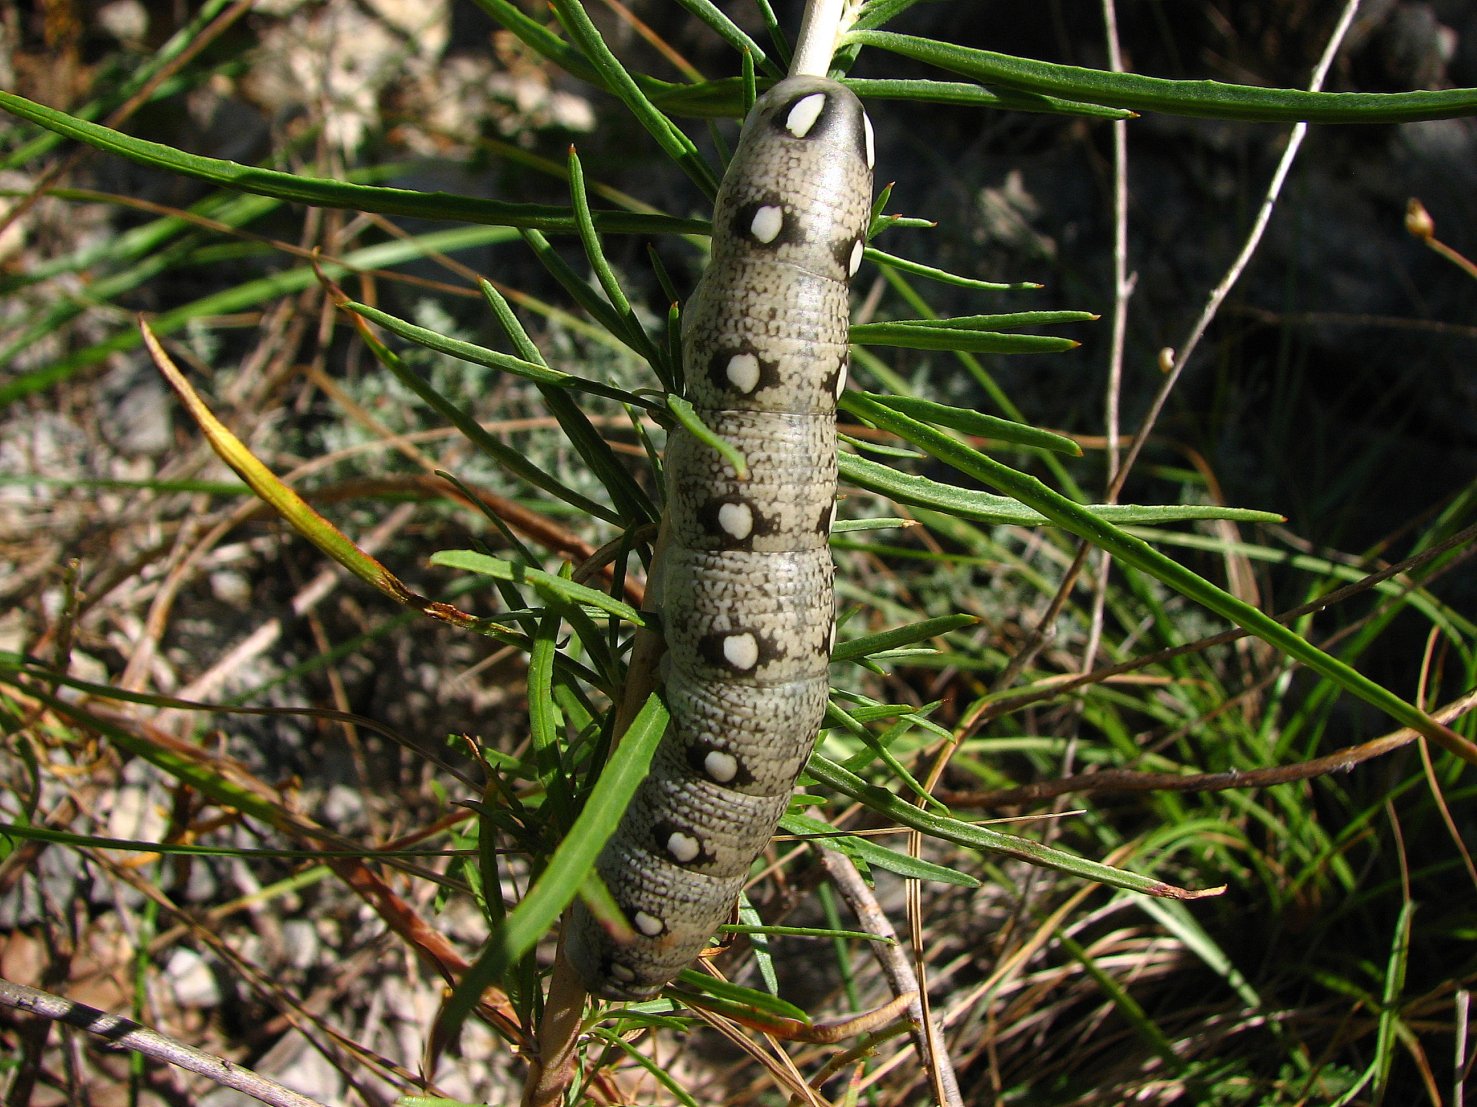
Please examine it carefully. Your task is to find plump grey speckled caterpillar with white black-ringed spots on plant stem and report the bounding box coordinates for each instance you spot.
[566,77,873,999]
